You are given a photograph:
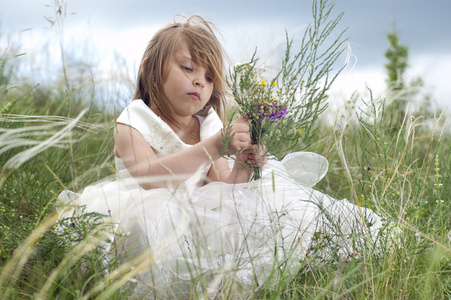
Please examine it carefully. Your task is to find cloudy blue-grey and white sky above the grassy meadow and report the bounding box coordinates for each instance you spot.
[0,0,451,110]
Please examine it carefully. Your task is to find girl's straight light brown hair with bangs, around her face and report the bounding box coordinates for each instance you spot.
[133,15,226,125]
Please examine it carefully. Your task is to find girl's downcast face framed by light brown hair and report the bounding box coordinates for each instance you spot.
[163,44,213,117]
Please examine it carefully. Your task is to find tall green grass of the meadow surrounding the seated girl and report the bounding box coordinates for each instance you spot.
[0,1,451,299]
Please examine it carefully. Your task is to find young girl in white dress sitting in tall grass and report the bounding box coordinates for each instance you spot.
[60,16,392,297]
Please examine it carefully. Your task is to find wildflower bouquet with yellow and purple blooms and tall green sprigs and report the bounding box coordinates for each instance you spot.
[229,0,345,179]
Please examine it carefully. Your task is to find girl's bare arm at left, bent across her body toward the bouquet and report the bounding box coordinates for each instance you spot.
[114,118,252,189]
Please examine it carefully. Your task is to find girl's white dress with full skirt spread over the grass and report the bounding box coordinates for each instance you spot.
[60,100,392,294]
